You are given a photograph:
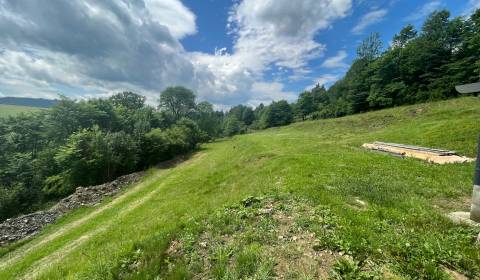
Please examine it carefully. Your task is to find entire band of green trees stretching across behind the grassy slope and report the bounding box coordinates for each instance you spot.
[0,10,480,221]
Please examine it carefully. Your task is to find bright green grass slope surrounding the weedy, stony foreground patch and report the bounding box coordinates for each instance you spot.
[0,97,480,279]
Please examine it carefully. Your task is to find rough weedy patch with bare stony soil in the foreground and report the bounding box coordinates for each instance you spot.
[150,196,382,279]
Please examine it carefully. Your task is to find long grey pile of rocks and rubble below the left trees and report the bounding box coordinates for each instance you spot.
[0,172,143,246]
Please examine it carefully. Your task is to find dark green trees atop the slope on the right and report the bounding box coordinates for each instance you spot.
[294,10,480,119]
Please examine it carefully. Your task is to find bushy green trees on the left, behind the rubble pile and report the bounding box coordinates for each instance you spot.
[0,86,293,220]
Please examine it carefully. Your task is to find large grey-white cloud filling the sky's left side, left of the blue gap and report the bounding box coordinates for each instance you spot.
[0,0,199,103]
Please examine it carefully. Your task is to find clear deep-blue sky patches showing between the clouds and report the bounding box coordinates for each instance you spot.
[182,0,478,92]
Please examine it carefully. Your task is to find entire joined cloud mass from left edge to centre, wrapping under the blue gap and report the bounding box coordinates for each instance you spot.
[0,0,352,106]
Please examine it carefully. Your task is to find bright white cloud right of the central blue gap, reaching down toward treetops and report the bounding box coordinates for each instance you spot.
[192,0,352,103]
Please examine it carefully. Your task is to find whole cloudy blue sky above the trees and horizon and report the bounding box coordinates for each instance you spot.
[0,0,480,108]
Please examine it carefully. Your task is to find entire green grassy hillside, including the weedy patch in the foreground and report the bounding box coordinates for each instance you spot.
[0,98,480,279]
